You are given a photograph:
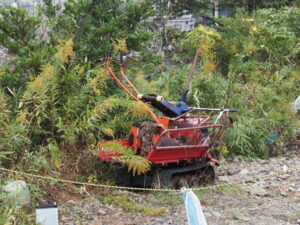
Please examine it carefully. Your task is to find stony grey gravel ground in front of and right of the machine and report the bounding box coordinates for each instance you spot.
[59,156,300,225]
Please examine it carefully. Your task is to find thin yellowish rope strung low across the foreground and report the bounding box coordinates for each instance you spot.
[0,167,300,193]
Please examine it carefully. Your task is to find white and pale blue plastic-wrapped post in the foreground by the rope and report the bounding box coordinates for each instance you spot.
[181,188,207,225]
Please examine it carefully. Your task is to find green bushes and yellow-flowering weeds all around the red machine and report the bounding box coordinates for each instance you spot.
[0,0,300,221]
